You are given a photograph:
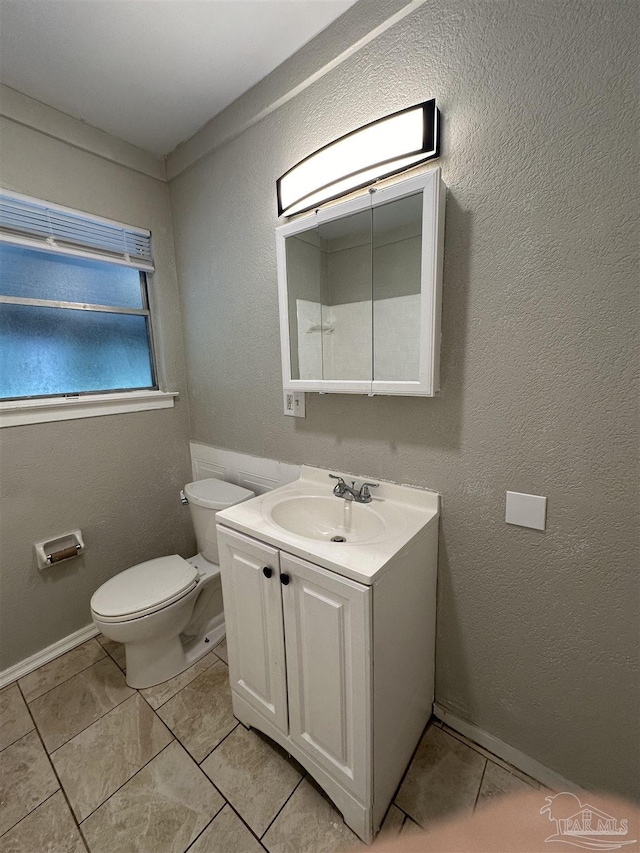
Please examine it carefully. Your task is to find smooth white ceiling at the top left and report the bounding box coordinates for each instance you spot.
[0,0,356,156]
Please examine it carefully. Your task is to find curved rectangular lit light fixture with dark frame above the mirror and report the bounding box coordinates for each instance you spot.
[276,98,440,216]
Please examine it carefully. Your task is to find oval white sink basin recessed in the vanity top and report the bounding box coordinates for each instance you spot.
[269,495,386,542]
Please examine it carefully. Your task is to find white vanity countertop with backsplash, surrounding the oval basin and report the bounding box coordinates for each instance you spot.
[216,465,440,585]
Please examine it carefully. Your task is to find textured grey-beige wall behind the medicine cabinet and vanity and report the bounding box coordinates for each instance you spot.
[169,0,638,795]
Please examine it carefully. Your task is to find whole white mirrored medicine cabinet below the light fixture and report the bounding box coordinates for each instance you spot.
[276,168,445,397]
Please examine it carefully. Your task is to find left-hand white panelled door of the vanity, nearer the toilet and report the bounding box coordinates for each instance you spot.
[218,527,287,734]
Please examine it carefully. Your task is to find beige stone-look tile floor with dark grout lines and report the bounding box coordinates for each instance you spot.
[0,636,539,853]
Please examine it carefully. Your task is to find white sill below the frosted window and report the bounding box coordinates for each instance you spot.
[0,391,178,428]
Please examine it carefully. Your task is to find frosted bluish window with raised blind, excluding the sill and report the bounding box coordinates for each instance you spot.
[0,192,158,404]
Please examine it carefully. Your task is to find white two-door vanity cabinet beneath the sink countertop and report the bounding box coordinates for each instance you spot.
[217,517,438,843]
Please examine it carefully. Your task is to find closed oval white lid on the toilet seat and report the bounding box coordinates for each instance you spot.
[91,554,198,618]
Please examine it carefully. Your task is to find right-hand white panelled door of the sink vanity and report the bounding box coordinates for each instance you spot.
[280,553,371,800]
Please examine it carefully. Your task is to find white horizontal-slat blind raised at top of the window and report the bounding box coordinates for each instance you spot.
[0,190,154,272]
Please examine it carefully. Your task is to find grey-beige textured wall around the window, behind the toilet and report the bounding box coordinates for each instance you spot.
[0,116,195,670]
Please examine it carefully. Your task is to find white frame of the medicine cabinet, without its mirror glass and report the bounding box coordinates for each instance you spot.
[276,167,446,397]
